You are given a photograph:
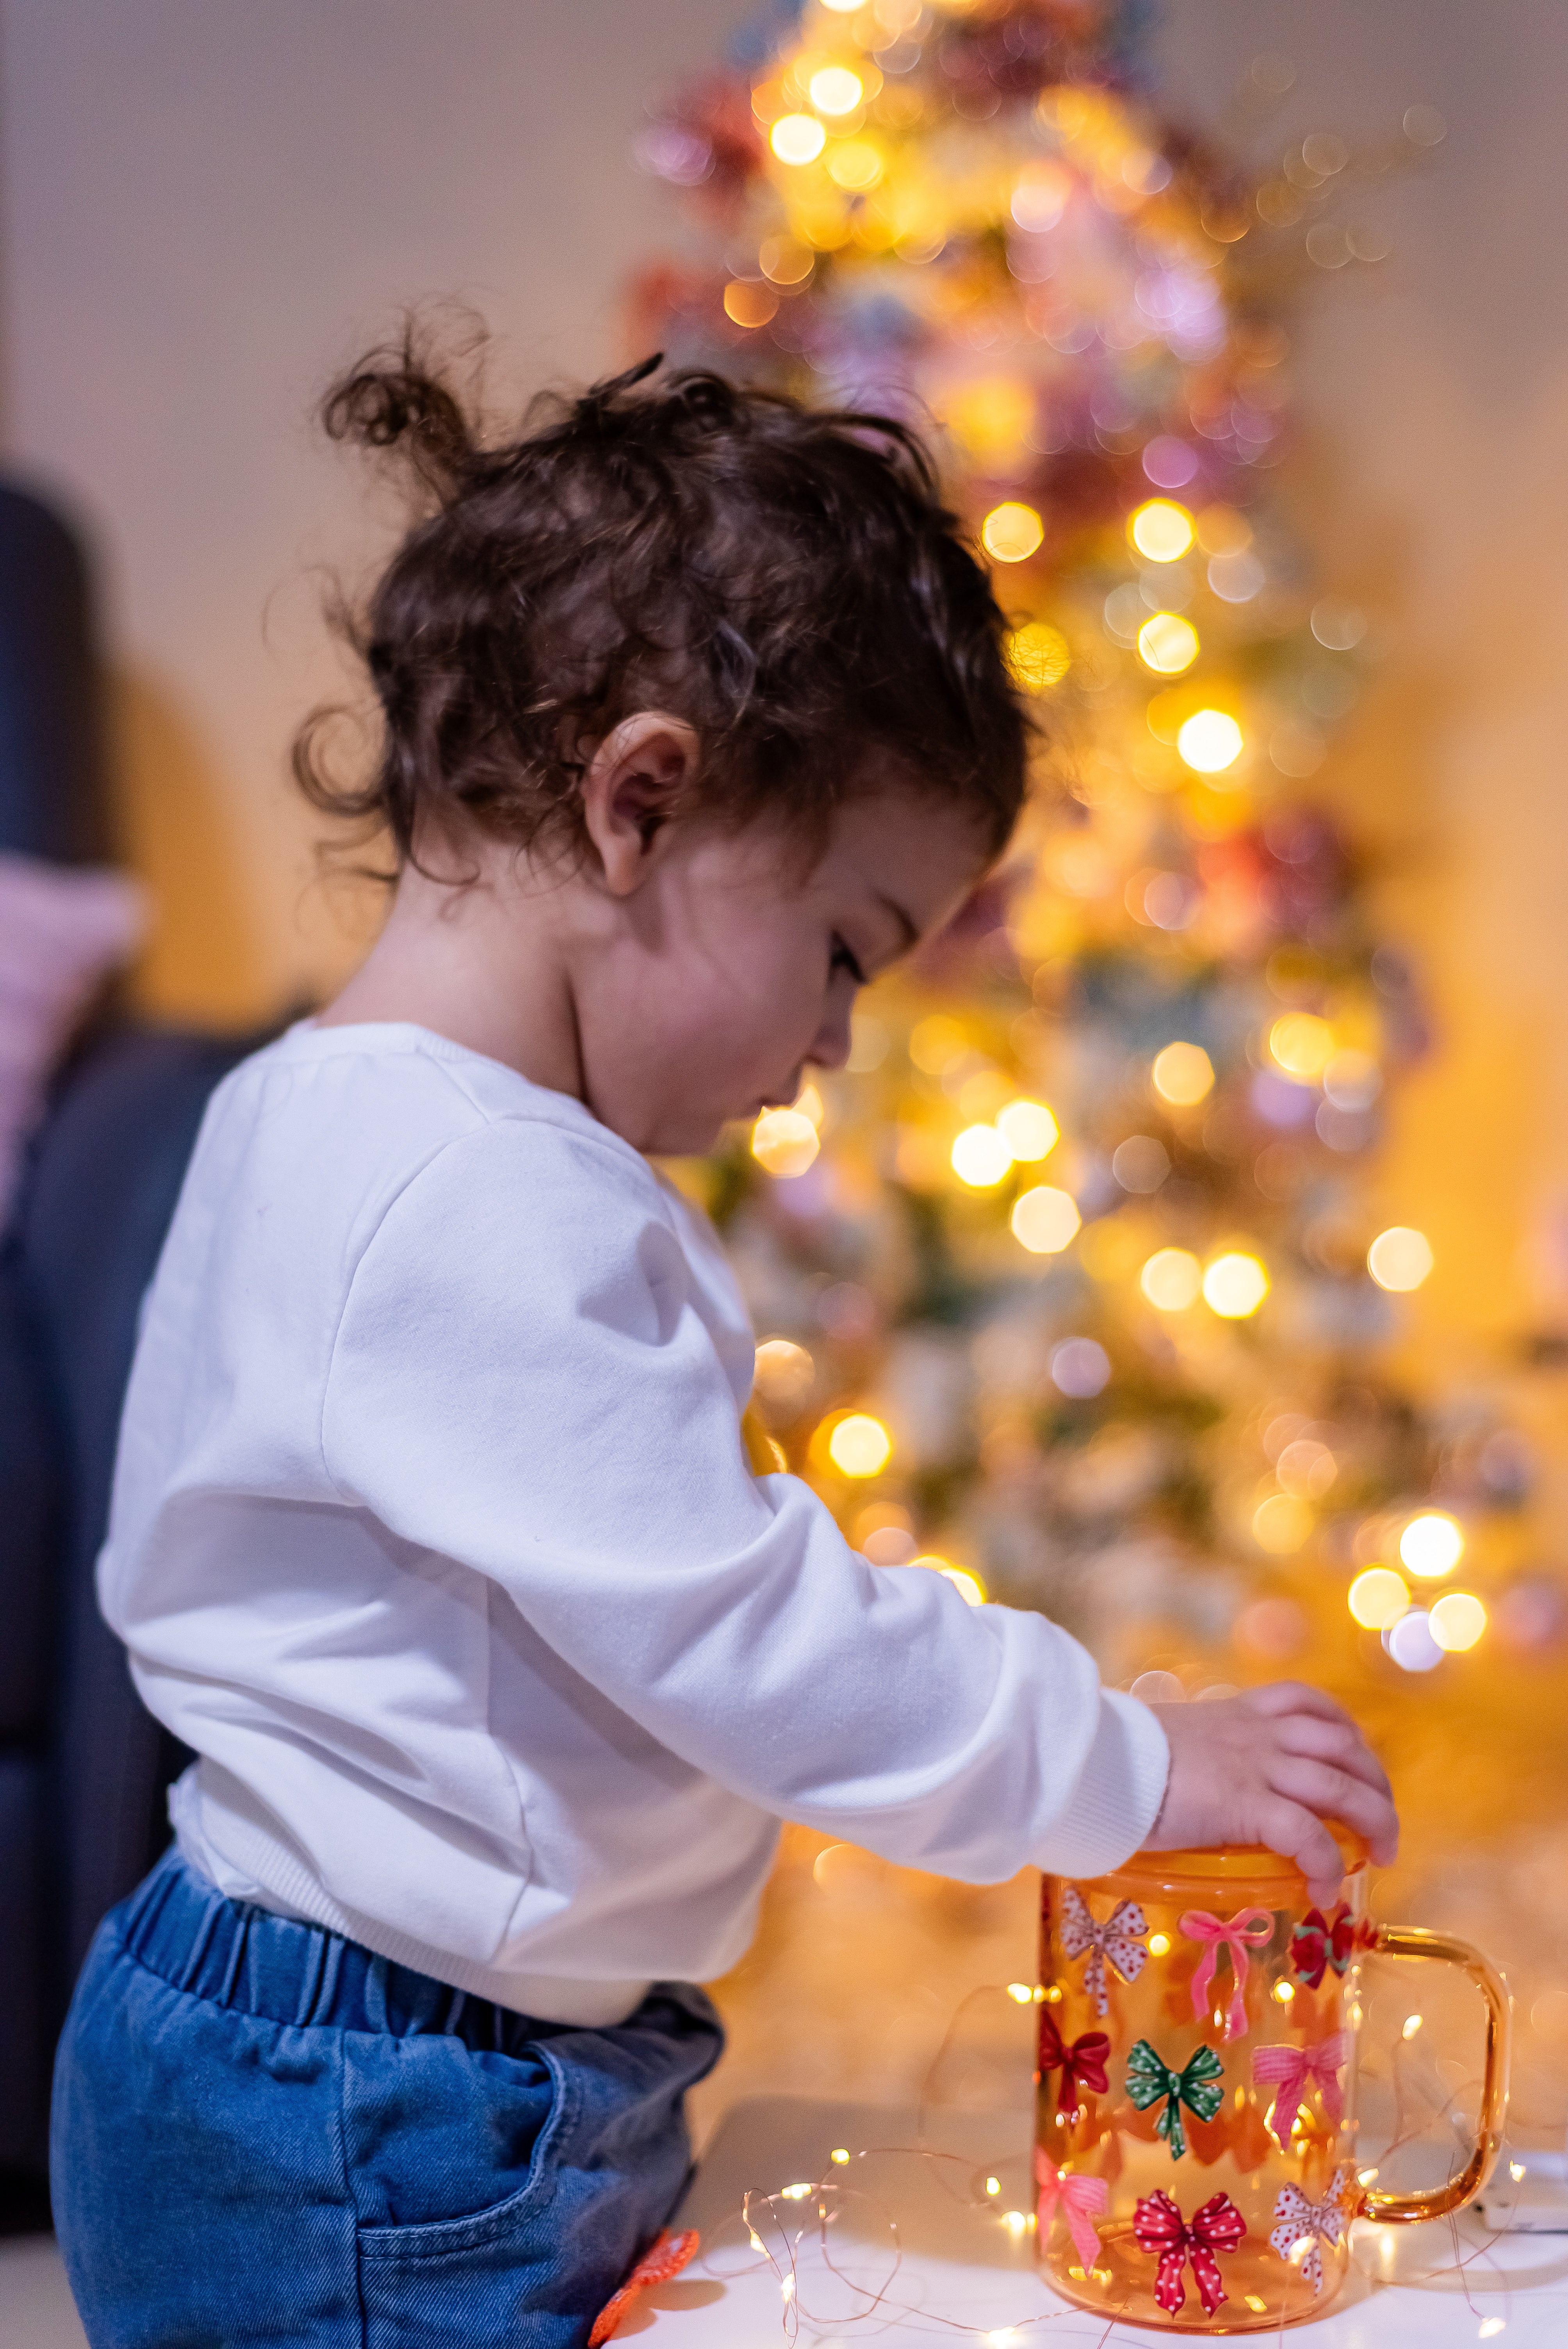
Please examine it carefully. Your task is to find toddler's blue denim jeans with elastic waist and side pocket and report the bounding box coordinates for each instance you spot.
[52,1854,723,2349]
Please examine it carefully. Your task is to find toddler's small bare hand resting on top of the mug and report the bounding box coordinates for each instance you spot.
[1146,1679,1399,1903]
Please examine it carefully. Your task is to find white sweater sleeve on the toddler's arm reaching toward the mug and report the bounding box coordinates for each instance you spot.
[322,1121,1169,1882]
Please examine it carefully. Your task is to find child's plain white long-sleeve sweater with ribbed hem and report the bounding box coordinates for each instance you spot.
[99,1024,1167,2023]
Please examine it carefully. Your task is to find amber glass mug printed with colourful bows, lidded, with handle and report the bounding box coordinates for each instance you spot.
[1035,1837,1507,2333]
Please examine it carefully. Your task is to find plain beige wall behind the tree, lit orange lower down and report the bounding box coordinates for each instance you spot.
[0,0,1568,1465]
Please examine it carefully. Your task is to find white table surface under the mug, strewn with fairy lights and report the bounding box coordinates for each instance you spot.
[615,2098,1568,2349]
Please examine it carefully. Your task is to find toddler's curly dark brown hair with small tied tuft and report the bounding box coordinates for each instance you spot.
[293,331,1028,869]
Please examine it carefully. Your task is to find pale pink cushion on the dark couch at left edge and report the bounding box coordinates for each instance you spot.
[0,853,146,1221]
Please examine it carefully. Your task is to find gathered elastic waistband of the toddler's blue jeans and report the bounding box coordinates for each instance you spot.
[110,1849,718,2055]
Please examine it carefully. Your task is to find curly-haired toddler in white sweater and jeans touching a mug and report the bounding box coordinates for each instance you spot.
[54,348,1394,2349]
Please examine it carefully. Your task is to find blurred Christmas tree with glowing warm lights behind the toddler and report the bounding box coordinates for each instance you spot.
[636,0,1561,1686]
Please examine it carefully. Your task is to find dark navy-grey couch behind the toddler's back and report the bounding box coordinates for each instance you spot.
[0,486,260,2198]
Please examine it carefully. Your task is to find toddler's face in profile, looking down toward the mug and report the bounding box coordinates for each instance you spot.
[573,780,988,1156]
